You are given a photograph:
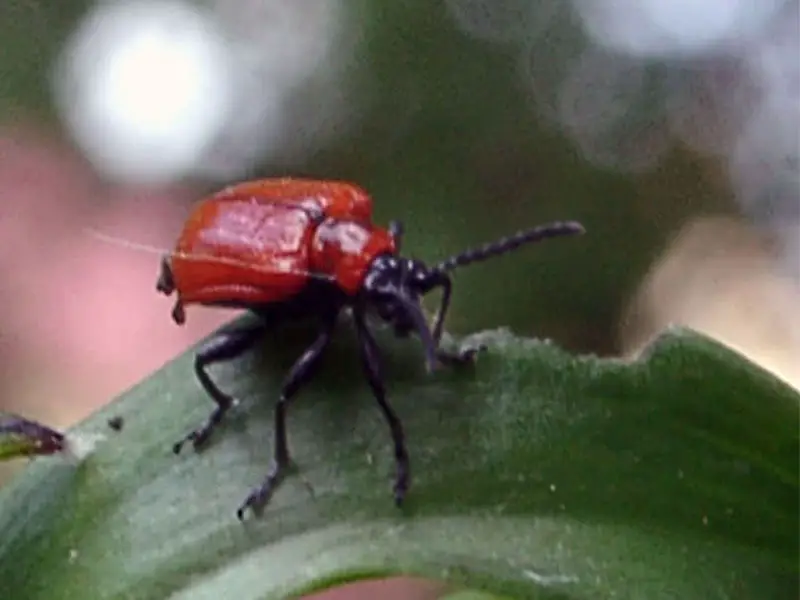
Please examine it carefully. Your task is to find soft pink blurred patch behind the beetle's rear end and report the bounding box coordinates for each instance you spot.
[0,127,232,426]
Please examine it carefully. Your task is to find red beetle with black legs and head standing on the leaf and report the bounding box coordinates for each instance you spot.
[156,178,584,520]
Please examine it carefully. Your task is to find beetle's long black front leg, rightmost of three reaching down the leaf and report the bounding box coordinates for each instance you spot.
[353,309,410,506]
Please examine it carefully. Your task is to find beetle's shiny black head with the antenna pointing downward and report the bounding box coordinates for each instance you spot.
[362,254,436,370]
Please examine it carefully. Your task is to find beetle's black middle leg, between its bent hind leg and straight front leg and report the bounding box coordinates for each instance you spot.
[236,313,337,521]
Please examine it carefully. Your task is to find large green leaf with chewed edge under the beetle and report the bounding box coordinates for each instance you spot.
[0,318,800,600]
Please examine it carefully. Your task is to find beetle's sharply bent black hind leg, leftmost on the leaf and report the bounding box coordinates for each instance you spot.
[172,323,264,454]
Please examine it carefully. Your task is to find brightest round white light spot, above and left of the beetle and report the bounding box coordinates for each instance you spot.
[56,0,233,183]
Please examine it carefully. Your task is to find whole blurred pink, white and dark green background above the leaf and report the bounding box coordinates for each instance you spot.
[0,0,800,478]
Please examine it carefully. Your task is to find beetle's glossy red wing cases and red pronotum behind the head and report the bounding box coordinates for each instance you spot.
[163,179,396,314]
